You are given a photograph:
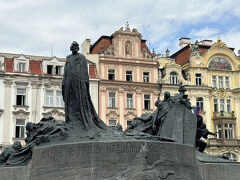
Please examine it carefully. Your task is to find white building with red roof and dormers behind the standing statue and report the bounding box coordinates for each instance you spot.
[0,53,99,151]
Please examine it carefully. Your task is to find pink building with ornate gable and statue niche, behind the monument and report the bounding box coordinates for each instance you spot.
[90,27,159,129]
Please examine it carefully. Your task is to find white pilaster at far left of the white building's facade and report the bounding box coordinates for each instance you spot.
[3,80,13,146]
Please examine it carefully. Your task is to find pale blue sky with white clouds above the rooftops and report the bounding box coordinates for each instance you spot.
[0,0,240,57]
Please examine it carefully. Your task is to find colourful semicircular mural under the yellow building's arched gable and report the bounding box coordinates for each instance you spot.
[208,57,232,70]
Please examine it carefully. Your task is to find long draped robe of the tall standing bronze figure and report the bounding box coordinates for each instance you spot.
[62,53,106,131]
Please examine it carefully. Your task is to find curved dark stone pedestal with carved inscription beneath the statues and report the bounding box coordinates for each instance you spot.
[0,141,240,180]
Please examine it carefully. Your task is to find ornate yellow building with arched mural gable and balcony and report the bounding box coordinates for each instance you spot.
[157,38,240,160]
